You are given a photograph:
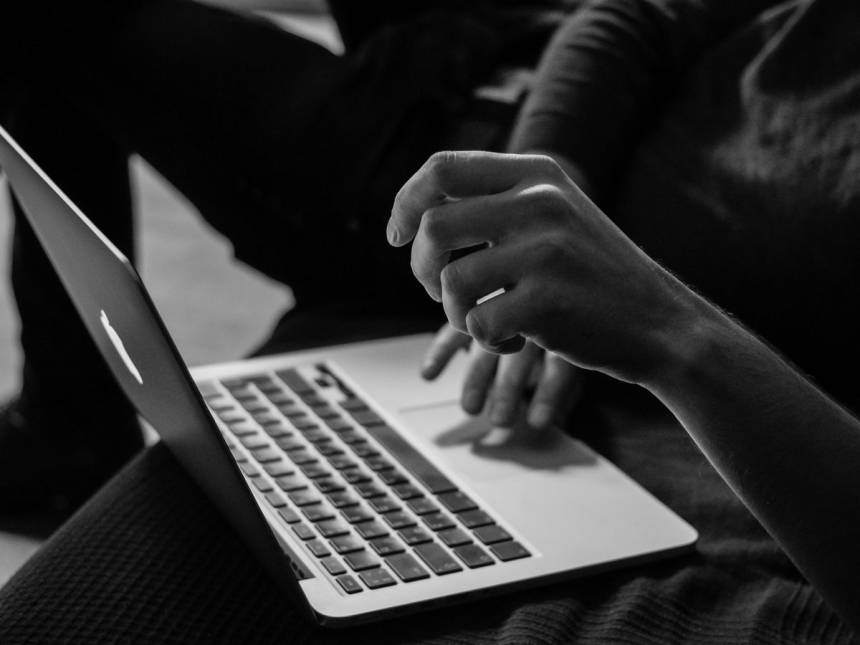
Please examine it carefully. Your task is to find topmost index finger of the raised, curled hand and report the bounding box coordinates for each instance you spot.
[387,151,561,246]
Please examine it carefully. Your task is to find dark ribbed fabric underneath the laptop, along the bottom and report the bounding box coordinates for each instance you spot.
[0,311,850,644]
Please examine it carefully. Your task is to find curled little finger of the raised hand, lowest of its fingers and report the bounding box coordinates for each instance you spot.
[466,284,533,354]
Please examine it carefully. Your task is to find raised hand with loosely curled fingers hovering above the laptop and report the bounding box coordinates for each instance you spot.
[388,152,689,382]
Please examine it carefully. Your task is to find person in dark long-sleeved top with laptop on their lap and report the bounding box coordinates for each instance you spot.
[0,0,860,643]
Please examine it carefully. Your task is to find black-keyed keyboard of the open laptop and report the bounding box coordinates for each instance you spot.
[198,365,531,594]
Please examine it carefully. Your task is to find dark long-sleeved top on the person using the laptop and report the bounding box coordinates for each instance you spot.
[513,0,860,409]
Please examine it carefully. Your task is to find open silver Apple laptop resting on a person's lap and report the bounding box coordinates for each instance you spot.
[0,128,697,627]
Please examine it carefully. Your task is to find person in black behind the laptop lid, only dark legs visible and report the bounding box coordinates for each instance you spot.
[0,0,563,511]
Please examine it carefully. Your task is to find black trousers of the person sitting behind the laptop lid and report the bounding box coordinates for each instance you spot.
[1,2,502,432]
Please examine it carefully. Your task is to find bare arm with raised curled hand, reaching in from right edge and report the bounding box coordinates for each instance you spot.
[389,153,860,629]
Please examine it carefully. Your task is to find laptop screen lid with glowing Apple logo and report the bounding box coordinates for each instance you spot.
[0,127,310,606]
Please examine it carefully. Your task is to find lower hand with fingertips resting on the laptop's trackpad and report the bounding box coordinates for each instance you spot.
[421,324,582,430]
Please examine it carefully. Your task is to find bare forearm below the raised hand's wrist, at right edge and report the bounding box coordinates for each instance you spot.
[643,290,860,629]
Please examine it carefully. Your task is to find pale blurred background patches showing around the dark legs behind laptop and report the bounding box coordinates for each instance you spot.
[0,0,341,586]
